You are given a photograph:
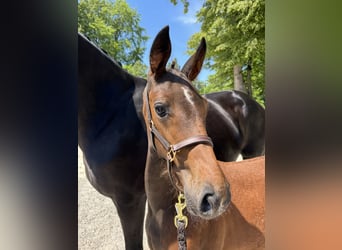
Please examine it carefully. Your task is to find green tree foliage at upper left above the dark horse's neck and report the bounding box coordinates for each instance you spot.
[78,0,148,67]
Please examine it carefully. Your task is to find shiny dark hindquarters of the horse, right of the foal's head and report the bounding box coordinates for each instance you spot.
[205,90,265,161]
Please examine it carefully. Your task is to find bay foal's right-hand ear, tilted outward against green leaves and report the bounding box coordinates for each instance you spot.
[182,37,207,81]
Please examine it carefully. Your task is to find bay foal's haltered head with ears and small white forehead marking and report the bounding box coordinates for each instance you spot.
[144,26,230,219]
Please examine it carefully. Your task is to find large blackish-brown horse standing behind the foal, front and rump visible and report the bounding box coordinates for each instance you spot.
[78,28,265,249]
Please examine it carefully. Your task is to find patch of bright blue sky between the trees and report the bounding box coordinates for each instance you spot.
[127,0,209,80]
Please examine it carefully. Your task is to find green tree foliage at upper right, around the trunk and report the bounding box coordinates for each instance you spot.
[188,0,265,104]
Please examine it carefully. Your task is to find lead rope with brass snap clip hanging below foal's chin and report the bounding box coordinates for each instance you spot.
[174,193,188,250]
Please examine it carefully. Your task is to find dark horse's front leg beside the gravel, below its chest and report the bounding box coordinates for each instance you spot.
[112,194,146,250]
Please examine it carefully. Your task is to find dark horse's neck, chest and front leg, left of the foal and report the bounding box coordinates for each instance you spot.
[78,34,147,250]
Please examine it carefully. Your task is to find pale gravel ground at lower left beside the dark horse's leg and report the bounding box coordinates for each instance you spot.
[78,148,149,250]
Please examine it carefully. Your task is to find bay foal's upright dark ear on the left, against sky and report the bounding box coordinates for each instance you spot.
[150,26,171,77]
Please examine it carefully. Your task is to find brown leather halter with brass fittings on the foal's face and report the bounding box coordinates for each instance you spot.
[145,86,213,192]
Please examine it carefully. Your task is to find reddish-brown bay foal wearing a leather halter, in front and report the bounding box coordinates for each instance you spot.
[143,27,264,250]
